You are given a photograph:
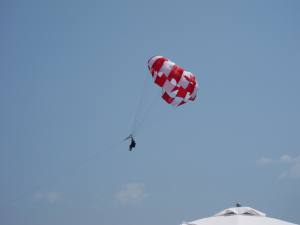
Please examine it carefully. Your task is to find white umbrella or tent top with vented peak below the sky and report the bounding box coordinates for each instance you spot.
[182,207,296,225]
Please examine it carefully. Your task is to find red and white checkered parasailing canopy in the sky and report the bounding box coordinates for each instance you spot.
[148,56,198,107]
